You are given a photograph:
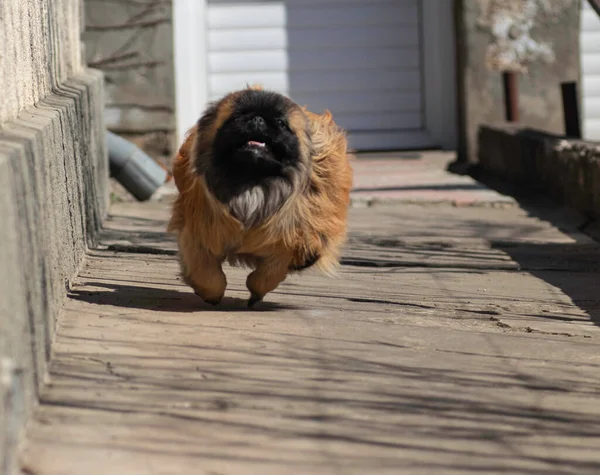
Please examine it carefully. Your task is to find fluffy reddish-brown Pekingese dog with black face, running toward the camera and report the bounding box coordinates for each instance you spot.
[169,86,352,307]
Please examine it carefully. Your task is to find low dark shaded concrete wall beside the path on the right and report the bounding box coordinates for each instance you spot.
[478,124,600,220]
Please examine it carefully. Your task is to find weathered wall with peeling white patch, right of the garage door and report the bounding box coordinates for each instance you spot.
[457,0,581,162]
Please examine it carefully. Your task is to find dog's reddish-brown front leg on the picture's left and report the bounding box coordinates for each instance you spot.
[179,234,227,305]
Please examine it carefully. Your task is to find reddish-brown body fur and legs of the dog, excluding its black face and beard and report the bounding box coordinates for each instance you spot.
[169,89,352,303]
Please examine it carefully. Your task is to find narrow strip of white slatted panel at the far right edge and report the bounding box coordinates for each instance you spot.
[580,0,600,140]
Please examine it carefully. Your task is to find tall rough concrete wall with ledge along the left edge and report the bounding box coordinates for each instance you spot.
[0,0,108,474]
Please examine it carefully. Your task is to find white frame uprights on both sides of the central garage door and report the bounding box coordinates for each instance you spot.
[173,0,457,149]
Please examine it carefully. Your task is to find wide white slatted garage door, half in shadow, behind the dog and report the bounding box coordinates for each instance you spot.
[207,0,431,150]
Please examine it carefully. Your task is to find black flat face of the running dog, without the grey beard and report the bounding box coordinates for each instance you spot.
[212,90,300,181]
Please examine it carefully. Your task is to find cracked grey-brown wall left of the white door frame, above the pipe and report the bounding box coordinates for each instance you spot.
[83,0,175,165]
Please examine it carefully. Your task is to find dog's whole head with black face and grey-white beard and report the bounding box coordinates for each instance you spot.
[196,89,311,231]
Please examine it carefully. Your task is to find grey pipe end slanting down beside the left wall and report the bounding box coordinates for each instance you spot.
[106,131,167,201]
